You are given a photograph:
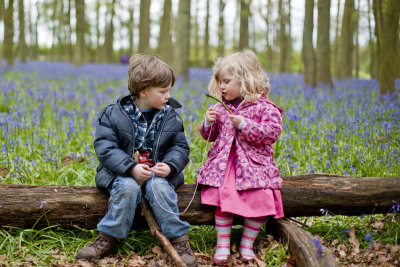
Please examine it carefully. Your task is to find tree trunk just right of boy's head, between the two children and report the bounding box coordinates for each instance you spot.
[174,0,191,78]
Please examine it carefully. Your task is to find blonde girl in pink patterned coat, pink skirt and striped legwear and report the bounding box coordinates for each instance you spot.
[197,50,283,264]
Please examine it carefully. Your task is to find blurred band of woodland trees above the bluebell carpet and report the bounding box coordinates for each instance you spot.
[0,0,400,97]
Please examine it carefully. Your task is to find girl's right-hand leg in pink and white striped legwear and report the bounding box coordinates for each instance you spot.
[239,217,265,261]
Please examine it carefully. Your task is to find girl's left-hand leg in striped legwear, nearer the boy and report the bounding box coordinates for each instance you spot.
[214,207,233,264]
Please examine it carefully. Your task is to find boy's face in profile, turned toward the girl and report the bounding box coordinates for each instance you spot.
[138,84,171,110]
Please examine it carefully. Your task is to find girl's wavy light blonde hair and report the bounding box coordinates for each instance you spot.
[208,49,271,102]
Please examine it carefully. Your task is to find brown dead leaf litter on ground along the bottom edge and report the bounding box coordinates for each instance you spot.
[0,217,400,267]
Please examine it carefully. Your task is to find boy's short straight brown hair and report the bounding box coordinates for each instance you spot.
[128,54,175,97]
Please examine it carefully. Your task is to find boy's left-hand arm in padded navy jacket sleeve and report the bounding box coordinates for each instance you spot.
[93,107,136,176]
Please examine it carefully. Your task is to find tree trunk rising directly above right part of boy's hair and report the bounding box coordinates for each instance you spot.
[158,0,174,64]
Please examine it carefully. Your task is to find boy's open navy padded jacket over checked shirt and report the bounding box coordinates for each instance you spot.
[93,96,190,188]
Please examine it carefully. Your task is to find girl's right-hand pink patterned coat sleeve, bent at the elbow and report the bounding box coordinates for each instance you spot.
[239,104,282,144]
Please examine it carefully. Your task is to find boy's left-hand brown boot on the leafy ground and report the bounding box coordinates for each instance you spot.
[76,232,117,261]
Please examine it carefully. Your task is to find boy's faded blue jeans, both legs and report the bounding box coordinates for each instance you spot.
[97,174,190,239]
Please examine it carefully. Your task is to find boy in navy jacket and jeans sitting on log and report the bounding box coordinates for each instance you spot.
[76,54,196,266]
